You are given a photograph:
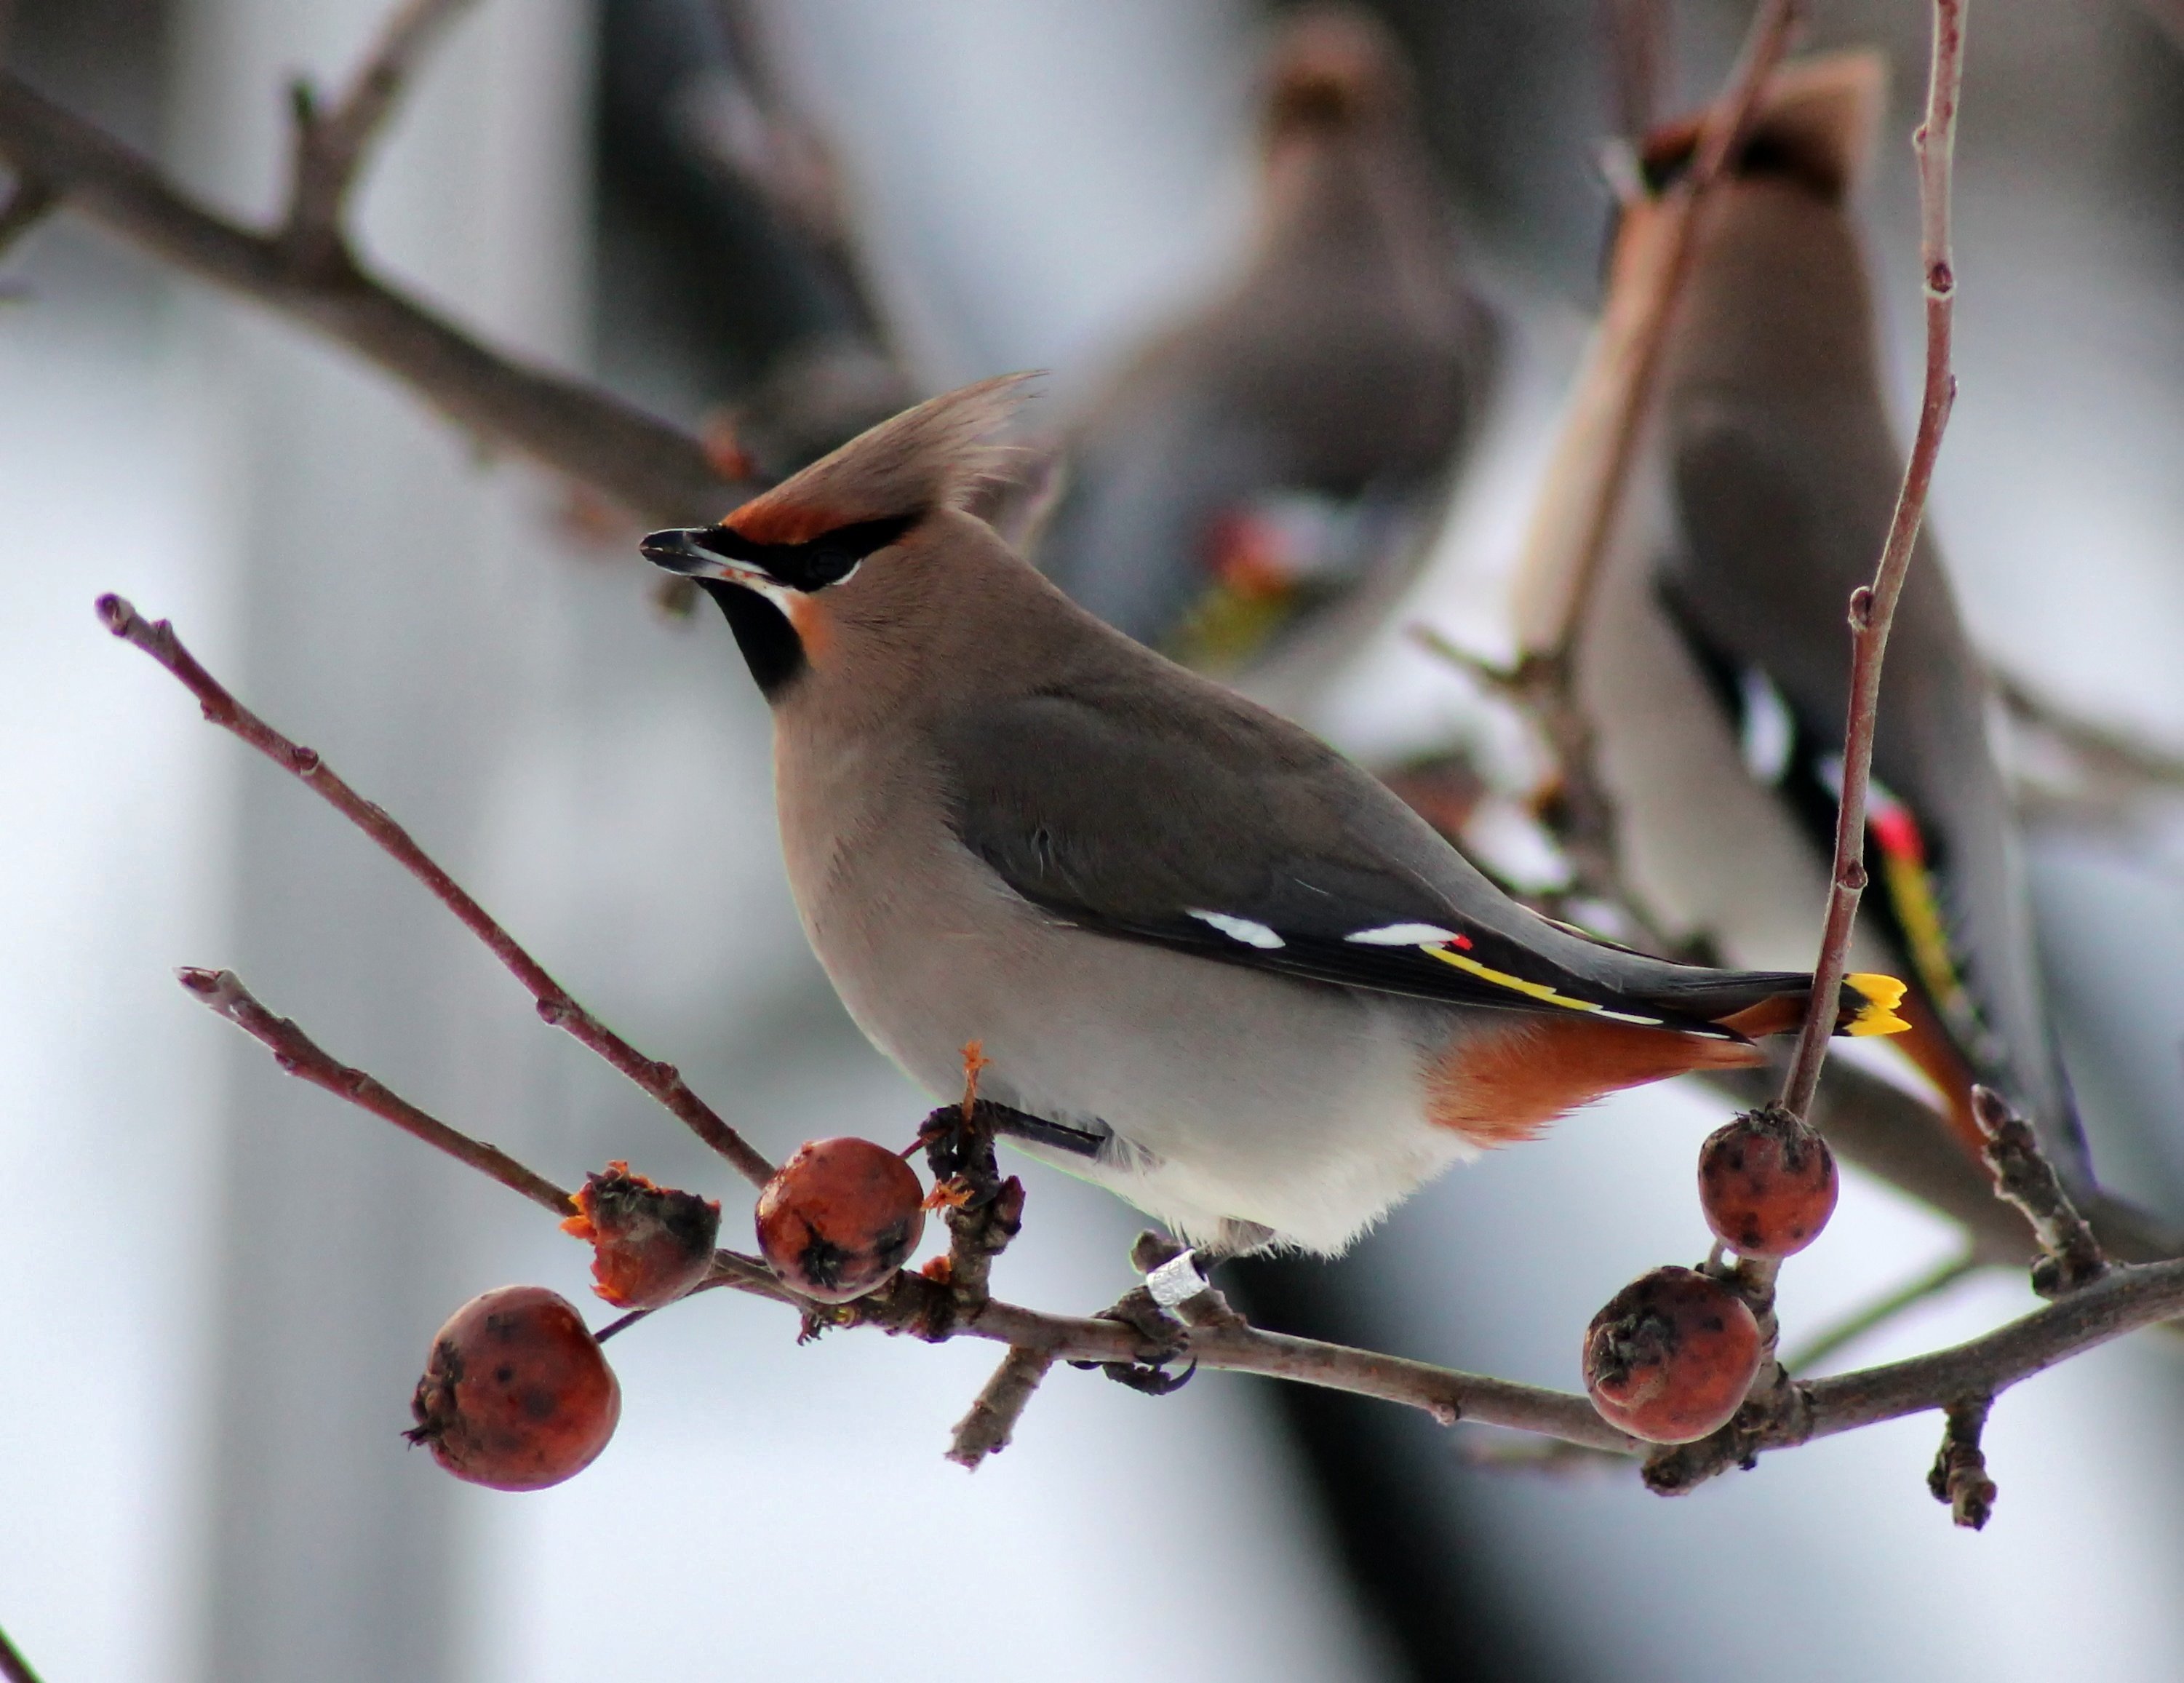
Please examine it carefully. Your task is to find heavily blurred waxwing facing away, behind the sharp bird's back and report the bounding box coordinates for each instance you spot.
[1035,7,1494,691]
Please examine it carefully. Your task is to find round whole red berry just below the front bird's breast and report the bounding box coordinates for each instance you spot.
[758,1139,926,1302]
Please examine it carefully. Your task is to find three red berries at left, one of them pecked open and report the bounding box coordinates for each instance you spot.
[406,1139,926,1491]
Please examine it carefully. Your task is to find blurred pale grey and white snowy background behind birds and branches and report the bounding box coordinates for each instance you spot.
[0,0,2184,1683]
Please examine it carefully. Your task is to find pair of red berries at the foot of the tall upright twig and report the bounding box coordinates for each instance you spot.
[1585,1108,1837,1443]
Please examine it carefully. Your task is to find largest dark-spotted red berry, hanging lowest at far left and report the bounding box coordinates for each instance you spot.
[404,1285,623,1491]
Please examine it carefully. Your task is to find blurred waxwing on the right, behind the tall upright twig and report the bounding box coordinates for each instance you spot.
[1518,52,2092,1189]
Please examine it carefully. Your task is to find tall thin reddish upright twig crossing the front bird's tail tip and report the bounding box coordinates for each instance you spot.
[1782,0,1966,1117]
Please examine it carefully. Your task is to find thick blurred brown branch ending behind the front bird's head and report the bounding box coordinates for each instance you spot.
[0,70,756,522]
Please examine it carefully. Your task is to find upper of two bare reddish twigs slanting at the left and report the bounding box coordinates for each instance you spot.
[98,594,773,1187]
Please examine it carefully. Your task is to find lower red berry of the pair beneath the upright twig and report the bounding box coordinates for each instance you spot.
[1585,1268,1761,1443]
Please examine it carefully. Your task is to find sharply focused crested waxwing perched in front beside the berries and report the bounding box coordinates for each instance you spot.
[645,376,1902,1252]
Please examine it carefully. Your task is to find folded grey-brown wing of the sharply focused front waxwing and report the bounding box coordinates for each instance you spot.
[939,684,1804,1038]
